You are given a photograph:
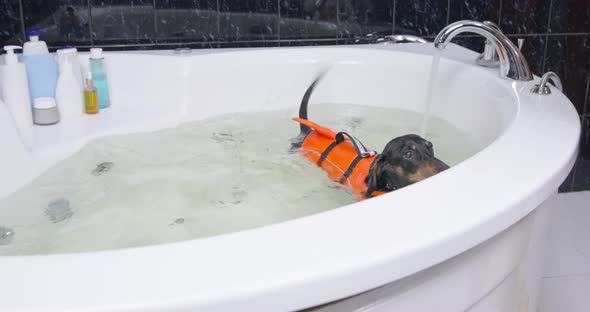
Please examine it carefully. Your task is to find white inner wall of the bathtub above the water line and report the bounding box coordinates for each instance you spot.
[0,48,517,244]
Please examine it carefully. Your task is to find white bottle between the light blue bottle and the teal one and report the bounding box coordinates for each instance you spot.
[55,57,84,120]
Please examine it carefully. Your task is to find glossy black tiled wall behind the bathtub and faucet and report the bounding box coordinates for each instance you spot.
[0,0,590,191]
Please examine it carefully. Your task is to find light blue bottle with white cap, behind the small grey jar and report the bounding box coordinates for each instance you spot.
[22,29,58,101]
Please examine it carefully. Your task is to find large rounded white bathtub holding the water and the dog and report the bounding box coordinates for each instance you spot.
[0,44,580,311]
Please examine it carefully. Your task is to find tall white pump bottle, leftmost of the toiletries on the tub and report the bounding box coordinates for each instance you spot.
[0,46,33,132]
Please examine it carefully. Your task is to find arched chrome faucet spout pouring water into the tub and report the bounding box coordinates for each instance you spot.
[434,21,533,81]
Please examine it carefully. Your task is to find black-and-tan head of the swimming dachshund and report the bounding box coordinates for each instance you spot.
[365,134,449,194]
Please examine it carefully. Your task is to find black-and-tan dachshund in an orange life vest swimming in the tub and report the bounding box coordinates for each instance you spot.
[291,75,449,198]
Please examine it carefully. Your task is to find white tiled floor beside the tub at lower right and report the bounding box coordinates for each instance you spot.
[539,192,590,312]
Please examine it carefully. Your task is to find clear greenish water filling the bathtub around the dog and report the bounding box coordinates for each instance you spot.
[0,104,477,255]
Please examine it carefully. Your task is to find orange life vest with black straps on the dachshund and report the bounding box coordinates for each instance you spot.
[293,118,385,198]
